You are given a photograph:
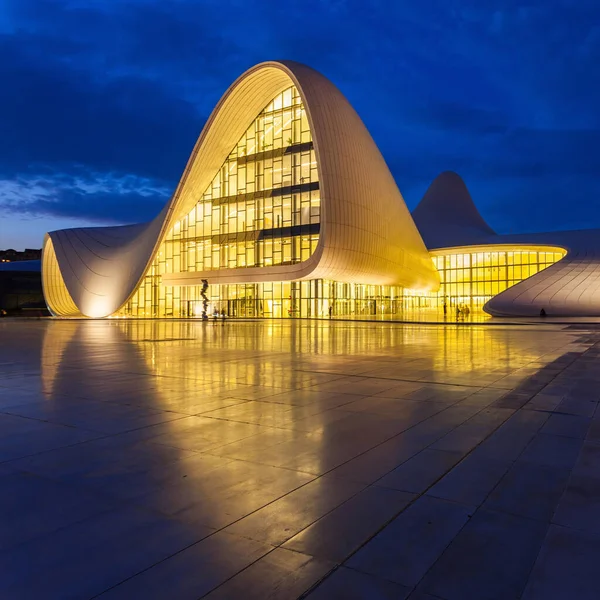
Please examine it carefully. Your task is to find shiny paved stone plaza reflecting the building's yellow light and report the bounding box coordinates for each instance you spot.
[0,319,600,600]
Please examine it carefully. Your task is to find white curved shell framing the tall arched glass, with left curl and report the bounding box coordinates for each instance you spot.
[42,62,439,317]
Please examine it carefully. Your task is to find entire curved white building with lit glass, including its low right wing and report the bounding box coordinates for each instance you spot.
[42,62,600,318]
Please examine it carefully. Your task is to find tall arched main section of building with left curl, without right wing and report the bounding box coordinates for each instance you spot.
[43,62,439,317]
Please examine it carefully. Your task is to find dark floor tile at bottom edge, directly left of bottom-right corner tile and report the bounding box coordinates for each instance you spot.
[418,509,548,600]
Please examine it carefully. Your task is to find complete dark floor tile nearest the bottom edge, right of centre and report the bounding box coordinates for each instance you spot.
[347,496,473,587]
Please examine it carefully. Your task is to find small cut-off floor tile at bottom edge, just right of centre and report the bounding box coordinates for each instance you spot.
[307,567,410,600]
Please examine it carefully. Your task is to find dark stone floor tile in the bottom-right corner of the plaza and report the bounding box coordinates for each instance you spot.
[523,525,600,600]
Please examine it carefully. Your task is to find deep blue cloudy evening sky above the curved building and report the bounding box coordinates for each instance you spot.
[0,0,600,249]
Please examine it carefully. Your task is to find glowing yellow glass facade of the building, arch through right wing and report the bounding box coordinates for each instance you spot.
[116,87,565,318]
